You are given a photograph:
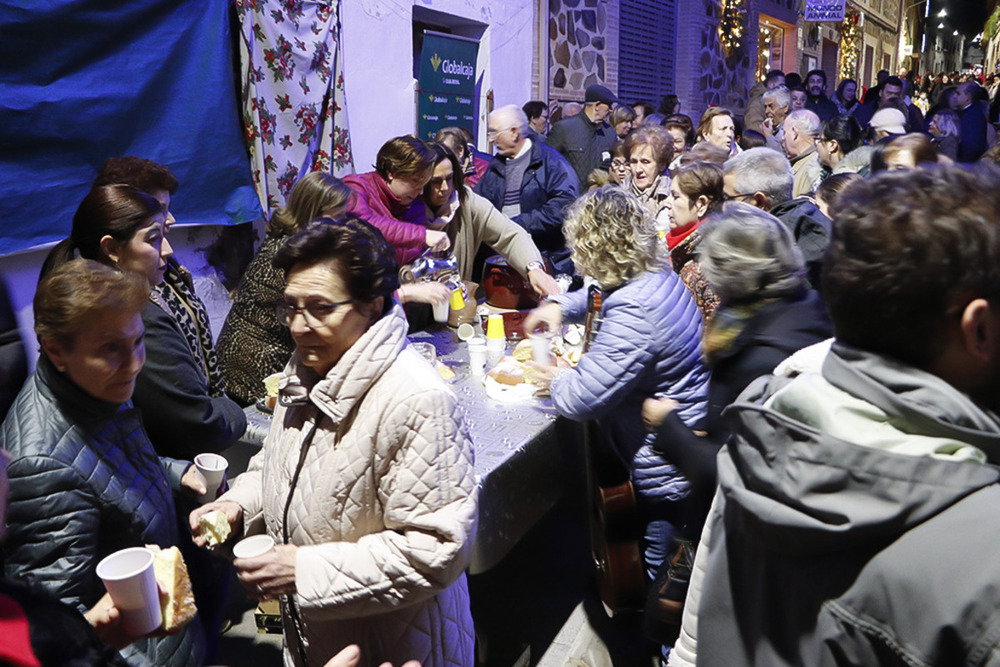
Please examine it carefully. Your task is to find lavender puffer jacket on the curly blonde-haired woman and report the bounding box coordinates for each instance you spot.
[551,269,709,502]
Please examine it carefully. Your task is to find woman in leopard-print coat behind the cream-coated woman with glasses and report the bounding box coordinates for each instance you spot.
[218,171,352,405]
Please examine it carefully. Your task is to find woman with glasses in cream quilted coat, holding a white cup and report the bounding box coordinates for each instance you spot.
[190,219,477,667]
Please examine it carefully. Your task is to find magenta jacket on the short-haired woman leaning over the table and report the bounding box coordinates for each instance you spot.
[344,171,427,266]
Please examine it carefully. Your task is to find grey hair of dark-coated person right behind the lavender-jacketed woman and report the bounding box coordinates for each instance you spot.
[698,202,806,302]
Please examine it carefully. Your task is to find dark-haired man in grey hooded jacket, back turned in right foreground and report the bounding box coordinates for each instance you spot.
[692,167,1000,667]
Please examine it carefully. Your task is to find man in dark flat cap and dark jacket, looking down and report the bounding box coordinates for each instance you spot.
[548,85,618,192]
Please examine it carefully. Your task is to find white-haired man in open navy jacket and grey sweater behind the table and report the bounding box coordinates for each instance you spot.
[475,104,578,275]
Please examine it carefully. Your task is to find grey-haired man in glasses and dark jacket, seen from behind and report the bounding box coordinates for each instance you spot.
[723,147,833,290]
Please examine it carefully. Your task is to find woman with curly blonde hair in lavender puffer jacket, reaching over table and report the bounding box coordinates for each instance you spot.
[524,186,708,576]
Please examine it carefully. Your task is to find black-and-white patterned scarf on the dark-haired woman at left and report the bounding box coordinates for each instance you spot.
[149,258,226,398]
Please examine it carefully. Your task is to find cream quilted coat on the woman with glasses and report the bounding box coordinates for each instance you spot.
[222,305,477,667]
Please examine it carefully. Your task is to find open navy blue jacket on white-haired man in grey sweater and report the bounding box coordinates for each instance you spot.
[474,141,579,275]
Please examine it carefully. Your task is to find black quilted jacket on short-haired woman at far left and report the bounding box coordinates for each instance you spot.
[0,354,204,665]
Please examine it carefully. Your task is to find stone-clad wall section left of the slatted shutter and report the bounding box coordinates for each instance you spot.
[548,0,618,101]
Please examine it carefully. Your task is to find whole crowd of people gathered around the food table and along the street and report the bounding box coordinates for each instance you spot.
[0,64,1000,667]
